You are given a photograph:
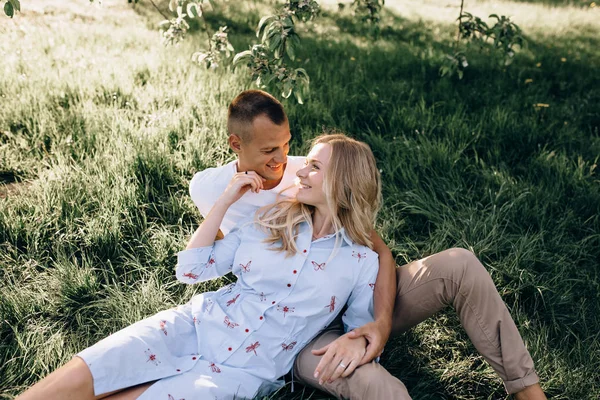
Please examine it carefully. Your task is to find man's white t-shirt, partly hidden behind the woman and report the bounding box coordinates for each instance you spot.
[190,156,306,235]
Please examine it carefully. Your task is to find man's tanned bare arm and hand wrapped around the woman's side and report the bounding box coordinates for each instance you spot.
[348,231,396,365]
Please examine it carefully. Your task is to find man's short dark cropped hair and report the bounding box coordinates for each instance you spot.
[227,90,287,141]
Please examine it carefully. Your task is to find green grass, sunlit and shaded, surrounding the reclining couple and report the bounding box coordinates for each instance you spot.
[0,1,600,400]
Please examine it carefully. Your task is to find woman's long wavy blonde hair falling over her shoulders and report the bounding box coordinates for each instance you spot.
[255,134,381,255]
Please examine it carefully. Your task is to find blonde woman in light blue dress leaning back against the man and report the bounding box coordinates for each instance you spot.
[21,135,381,400]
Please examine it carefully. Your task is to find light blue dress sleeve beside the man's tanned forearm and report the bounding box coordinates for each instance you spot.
[342,253,379,332]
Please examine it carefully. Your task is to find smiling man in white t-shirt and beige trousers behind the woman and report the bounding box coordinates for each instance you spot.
[190,90,546,400]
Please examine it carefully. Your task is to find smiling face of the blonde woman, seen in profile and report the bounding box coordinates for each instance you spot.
[296,143,331,207]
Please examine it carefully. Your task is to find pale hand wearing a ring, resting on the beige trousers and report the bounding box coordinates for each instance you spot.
[312,334,367,385]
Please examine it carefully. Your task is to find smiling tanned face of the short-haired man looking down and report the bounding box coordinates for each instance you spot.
[229,115,292,183]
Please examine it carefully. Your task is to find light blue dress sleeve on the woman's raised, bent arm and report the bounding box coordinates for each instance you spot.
[175,222,248,284]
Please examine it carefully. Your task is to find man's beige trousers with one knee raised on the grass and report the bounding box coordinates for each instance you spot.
[294,248,539,400]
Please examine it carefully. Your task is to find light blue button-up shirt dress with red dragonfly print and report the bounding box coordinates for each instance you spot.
[78,223,379,400]
